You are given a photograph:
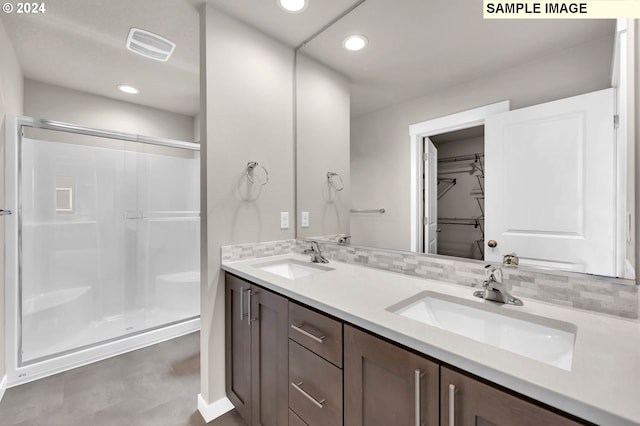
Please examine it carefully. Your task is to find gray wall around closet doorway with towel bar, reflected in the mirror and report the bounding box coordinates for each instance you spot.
[351,37,613,250]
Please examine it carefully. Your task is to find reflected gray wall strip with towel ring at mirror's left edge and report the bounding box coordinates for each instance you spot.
[296,53,351,238]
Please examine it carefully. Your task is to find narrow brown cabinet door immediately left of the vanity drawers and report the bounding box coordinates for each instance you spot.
[249,286,289,426]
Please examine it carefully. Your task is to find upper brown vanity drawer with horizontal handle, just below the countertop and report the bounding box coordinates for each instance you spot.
[289,302,342,367]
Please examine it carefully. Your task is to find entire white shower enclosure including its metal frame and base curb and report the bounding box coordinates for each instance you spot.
[5,117,200,385]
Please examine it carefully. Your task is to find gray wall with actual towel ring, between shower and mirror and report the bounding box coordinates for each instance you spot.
[200,4,295,404]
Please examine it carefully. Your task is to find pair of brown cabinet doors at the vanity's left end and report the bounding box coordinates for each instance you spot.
[225,274,289,426]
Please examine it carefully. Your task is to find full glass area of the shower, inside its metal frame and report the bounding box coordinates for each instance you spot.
[19,138,200,365]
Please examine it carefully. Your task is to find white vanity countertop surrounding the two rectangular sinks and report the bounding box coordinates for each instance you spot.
[222,254,640,426]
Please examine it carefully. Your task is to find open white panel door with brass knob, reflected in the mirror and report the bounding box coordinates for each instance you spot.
[485,89,617,275]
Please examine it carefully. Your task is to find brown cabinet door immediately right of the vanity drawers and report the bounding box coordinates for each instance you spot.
[344,326,440,426]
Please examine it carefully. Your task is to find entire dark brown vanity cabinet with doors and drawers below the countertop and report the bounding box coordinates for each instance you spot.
[226,273,588,426]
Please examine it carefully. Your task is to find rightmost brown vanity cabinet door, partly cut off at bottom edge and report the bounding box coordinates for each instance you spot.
[440,367,581,426]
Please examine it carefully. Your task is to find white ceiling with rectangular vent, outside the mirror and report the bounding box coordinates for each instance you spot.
[0,0,355,115]
